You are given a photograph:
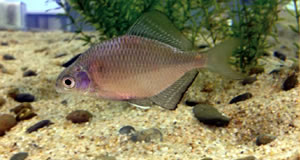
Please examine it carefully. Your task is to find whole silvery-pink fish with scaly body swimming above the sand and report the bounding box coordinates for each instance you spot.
[56,11,243,110]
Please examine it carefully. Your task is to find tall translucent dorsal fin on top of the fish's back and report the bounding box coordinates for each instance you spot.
[127,11,193,51]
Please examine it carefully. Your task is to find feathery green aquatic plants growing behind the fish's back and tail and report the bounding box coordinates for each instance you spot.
[57,0,290,72]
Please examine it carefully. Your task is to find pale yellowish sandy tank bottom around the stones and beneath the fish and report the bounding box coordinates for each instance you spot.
[0,24,300,160]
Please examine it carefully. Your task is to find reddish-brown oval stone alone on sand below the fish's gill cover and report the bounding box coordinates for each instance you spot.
[66,110,93,123]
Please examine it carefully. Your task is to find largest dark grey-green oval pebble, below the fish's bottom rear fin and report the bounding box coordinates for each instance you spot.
[193,104,230,127]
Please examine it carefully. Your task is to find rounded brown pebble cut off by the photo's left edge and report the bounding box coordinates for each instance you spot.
[0,114,17,136]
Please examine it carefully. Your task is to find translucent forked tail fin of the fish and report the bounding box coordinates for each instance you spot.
[205,39,244,79]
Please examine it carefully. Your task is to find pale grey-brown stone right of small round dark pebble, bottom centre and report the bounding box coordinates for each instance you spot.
[130,128,163,142]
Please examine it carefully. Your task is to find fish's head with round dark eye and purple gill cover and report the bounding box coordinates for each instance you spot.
[56,64,92,94]
